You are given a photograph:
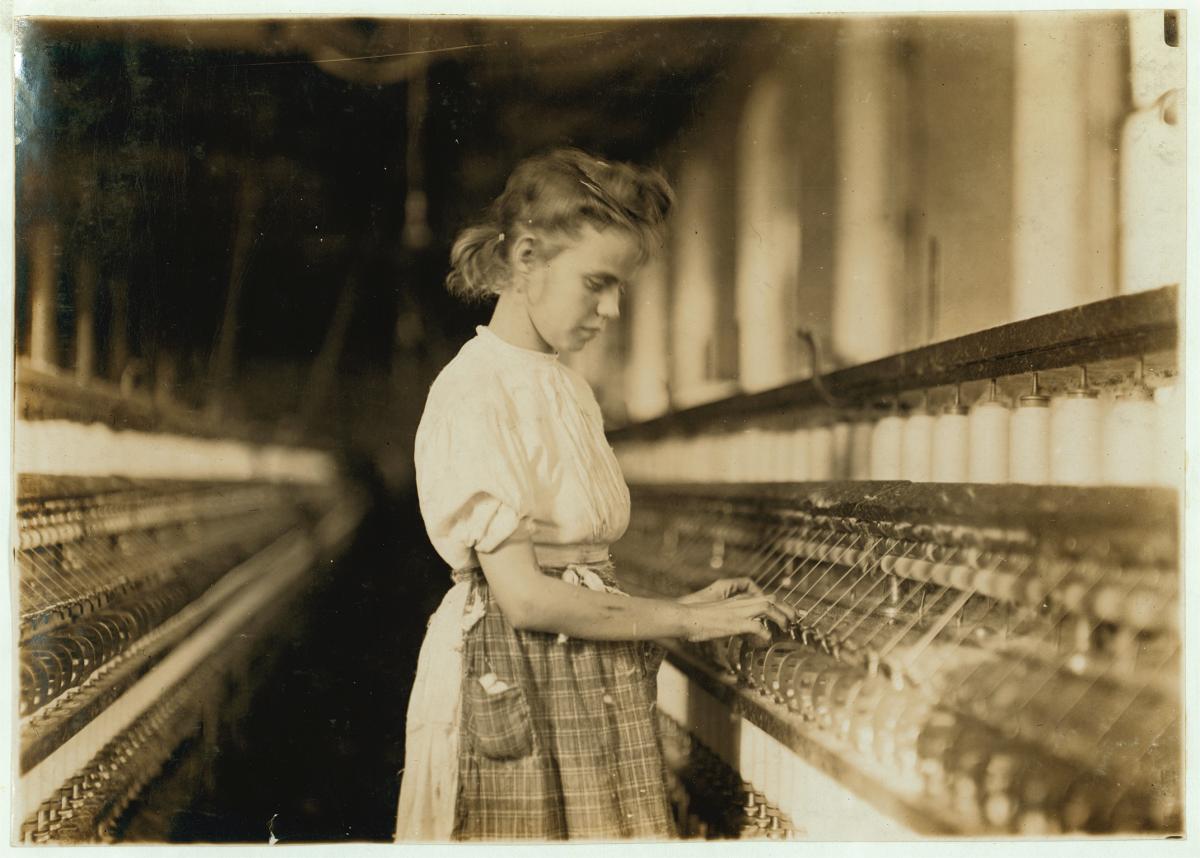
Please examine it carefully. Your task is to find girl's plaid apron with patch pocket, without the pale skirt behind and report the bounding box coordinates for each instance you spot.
[454,564,676,840]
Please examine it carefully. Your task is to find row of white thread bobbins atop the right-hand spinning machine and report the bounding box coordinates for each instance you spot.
[617,364,1183,486]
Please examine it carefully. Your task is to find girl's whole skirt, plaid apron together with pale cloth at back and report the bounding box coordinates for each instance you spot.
[396,545,676,841]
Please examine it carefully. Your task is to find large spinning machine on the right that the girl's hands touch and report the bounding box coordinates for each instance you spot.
[613,285,1183,839]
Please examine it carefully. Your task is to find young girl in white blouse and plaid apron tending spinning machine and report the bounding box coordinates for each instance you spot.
[396,150,794,840]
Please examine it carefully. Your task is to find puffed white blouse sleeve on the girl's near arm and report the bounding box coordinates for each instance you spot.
[414,400,533,569]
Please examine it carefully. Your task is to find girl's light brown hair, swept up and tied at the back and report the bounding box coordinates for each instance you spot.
[446,149,674,300]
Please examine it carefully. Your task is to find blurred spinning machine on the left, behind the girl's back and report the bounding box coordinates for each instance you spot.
[16,364,368,844]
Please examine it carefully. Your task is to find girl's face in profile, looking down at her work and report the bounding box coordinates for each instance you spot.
[523,224,638,352]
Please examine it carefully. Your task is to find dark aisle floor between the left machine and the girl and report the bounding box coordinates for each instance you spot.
[122,487,450,844]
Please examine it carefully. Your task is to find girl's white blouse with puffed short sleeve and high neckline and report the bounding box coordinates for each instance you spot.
[414,325,629,569]
